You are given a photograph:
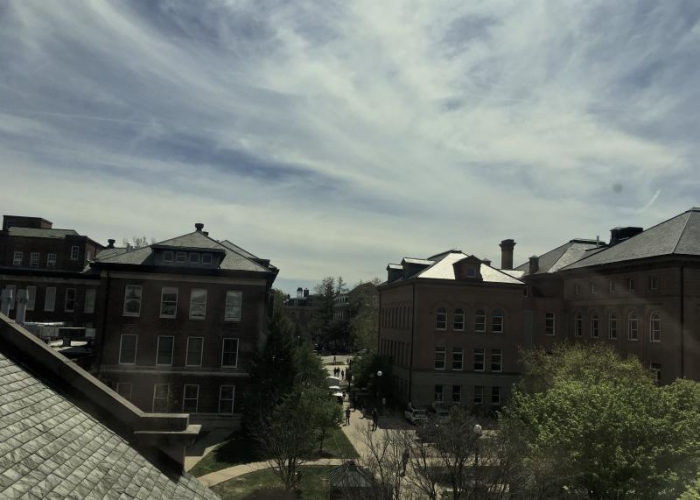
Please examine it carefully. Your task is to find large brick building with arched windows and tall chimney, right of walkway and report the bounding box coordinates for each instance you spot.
[378,208,700,407]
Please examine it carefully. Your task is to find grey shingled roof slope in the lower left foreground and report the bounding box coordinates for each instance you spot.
[0,354,219,500]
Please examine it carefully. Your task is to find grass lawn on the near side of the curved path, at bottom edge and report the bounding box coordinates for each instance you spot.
[211,465,333,500]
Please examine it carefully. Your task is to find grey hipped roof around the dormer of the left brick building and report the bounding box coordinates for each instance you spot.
[97,231,274,273]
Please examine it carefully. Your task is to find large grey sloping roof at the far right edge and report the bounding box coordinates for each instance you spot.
[563,207,700,270]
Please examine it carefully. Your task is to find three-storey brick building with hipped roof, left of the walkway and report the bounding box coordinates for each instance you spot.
[92,224,278,426]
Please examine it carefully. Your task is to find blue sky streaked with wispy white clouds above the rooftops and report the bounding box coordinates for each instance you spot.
[0,0,700,293]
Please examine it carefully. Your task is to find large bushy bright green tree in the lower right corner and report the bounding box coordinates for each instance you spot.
[500,345,700,499]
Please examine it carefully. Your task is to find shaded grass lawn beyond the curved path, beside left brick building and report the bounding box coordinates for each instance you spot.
[190,427,358,477]
